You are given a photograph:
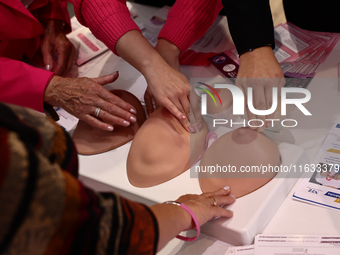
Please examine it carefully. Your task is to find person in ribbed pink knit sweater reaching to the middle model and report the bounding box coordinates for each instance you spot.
[70,0,222,131]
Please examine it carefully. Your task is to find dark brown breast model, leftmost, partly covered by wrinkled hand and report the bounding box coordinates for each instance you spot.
[72,90,145,155]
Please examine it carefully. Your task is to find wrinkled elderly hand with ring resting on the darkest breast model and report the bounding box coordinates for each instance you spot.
[44,72,137,131]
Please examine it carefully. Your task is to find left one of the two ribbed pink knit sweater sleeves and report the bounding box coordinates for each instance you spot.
[69,0,140,54]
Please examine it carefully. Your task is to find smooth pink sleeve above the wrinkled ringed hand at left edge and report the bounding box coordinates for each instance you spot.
[0,57,54,112]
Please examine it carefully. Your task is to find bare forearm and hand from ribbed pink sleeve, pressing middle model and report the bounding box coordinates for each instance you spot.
[115,30,190,132]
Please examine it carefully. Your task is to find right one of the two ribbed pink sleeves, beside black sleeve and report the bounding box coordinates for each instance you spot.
[158,0,223,53]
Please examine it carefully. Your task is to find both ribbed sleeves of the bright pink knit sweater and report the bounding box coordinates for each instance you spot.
[71,0,223,54]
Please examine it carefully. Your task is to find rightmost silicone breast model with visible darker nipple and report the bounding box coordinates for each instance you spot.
[199,128,280,197]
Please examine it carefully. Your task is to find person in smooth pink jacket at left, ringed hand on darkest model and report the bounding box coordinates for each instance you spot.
[0,0,136,131]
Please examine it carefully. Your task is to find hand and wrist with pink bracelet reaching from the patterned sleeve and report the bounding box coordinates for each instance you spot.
[151,187,236,250]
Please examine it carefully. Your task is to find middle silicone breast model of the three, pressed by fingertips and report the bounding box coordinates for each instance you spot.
[127,107,208,188]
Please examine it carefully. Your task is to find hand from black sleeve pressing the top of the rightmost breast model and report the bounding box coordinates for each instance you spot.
[236,46,284,132]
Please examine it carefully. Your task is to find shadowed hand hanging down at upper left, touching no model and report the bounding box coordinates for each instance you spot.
[40,20,75,76]
